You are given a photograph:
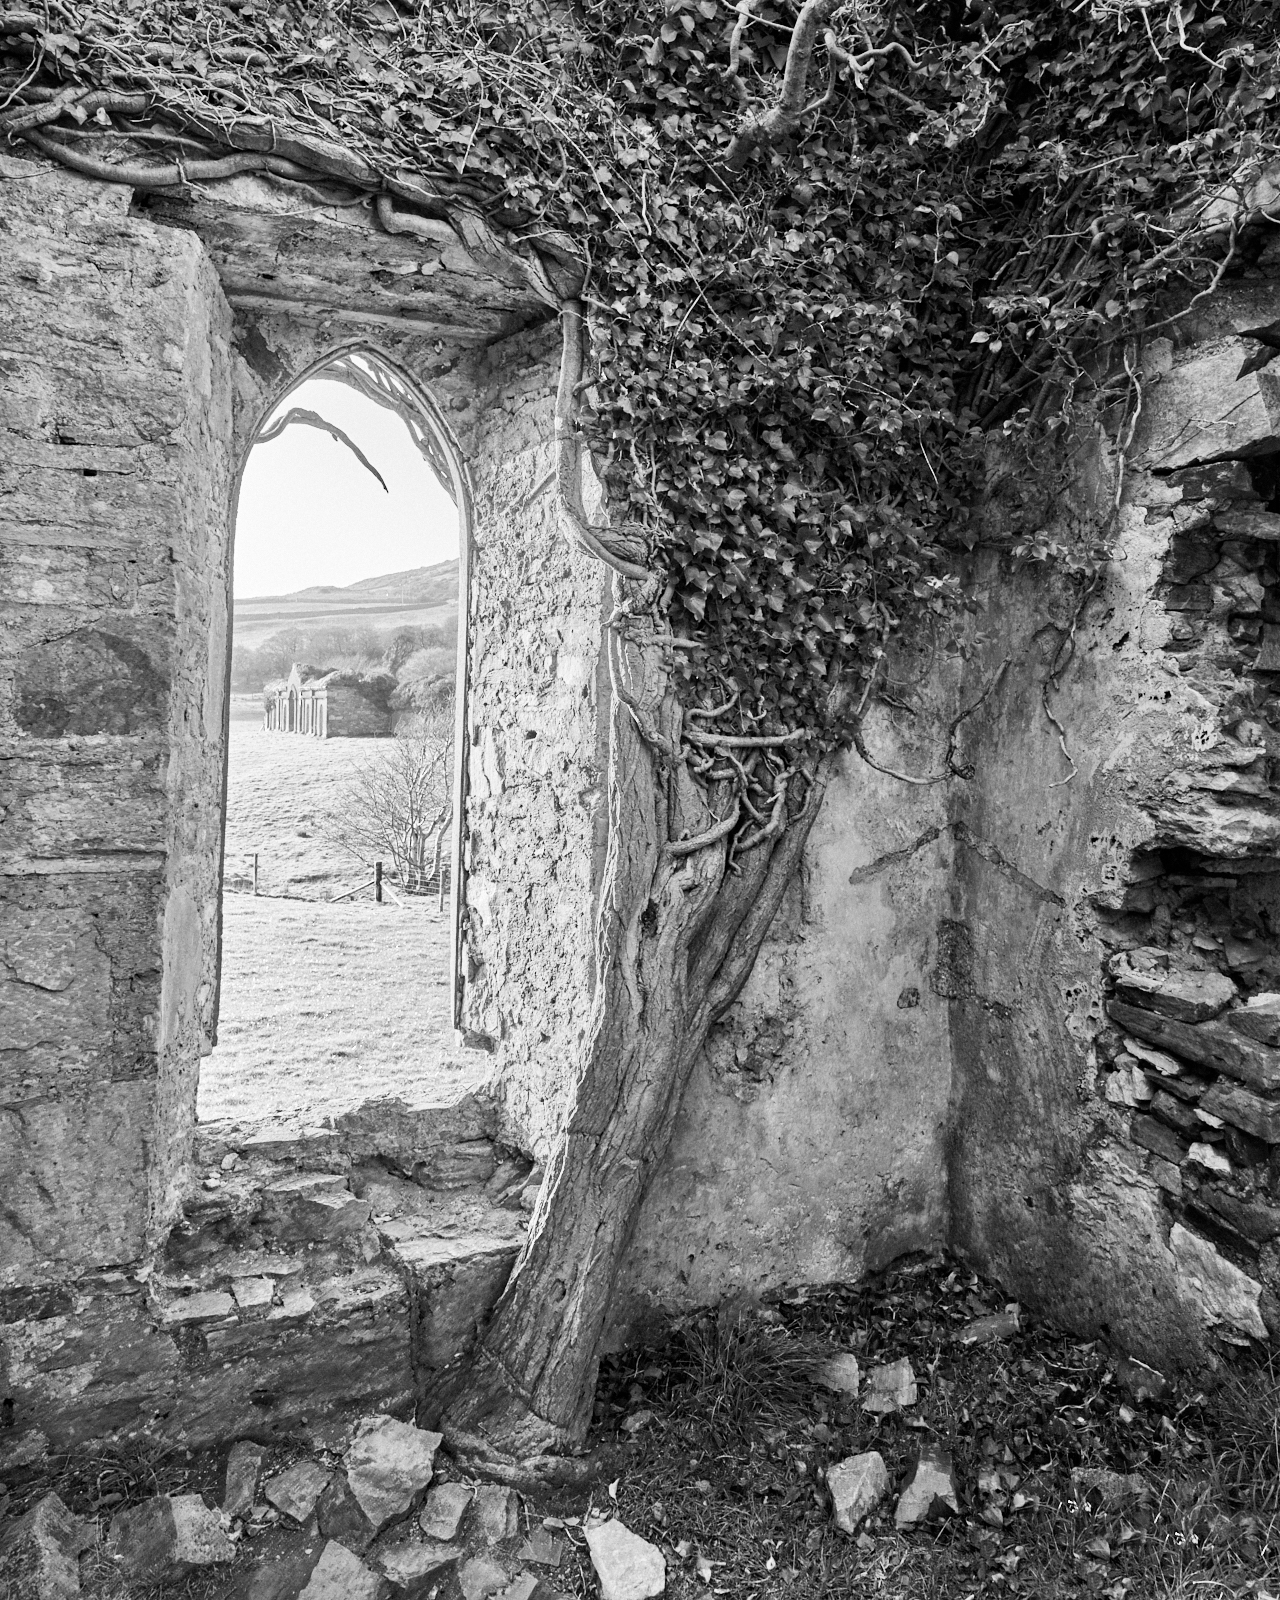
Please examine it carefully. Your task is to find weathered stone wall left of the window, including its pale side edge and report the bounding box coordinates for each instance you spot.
[0,157,230,1285]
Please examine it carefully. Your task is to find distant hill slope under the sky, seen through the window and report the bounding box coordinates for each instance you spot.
[234,562,458,648]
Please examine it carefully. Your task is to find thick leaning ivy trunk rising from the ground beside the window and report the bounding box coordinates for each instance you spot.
[422,617,822,1470]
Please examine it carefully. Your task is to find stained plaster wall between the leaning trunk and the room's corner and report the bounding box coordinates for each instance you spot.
[614,718,950,1338]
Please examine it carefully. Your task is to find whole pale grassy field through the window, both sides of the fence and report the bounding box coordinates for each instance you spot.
[198,696,488,1123]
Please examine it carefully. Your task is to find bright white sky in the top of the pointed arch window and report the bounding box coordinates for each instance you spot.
[234,378,458,600]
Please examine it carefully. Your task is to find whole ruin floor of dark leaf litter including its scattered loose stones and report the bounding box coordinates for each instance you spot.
[0,1258,1280,1600]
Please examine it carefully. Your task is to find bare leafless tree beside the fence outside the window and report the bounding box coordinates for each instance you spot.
[331,699,453,894]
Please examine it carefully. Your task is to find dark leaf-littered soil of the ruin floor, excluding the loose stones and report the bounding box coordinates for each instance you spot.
[0,1258,1280,1600]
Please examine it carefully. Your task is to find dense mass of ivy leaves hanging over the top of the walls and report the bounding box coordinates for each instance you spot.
[0,0,1280,746]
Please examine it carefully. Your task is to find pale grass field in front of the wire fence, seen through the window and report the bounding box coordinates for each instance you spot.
[198,902,488,1123]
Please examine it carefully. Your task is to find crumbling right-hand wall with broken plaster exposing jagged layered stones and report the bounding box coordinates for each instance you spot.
[944,283,1280,1365]
